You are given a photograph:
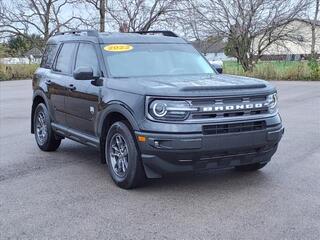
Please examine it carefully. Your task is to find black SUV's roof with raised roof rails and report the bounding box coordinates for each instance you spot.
[48,31,187,44]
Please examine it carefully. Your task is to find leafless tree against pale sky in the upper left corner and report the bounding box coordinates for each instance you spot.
[0,0,81,41]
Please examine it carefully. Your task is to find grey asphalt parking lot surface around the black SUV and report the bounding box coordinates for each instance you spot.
[0,80,320,240]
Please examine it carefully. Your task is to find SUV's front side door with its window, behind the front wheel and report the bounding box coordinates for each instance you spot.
[65,42,101,136]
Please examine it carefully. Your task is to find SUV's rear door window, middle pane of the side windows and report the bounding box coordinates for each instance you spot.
[54,43,77,74]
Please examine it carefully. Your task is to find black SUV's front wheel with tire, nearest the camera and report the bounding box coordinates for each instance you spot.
[105,122,145,189]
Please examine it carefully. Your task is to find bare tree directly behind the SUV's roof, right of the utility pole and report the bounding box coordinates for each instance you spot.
[108,0,179,31]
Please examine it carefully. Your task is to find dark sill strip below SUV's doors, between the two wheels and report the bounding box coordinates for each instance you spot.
[51,123,100,148]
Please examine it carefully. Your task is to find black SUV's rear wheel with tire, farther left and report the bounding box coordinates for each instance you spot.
[33,103,61,152]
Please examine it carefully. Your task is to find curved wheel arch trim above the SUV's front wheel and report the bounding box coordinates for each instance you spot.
[97,101,139,136]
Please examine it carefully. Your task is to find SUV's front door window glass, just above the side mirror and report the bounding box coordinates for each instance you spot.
[75,43,99,74]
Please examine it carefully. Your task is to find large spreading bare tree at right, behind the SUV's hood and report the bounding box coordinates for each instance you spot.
[190,0,309,71]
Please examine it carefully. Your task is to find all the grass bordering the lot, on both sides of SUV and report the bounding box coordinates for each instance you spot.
[0,61,320,81]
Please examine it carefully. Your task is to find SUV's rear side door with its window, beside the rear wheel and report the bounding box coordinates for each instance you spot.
[47,43,77,126]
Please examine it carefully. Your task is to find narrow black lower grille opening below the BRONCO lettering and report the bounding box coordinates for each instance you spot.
[202,121,266,135]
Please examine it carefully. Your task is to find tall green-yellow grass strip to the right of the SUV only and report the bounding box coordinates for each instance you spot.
[223,61,320,80]
